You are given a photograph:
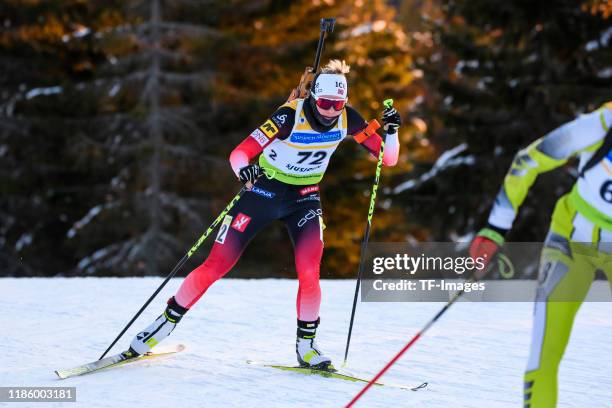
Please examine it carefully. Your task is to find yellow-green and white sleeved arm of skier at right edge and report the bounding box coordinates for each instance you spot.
[489,106,612,231]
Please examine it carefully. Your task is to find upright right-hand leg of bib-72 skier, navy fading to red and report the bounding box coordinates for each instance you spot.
[284,200,331,368]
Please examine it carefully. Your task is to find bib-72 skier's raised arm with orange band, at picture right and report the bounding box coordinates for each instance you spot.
[346,106,399,166]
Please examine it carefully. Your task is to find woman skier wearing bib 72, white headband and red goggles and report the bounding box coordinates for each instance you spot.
[124,60,401,369]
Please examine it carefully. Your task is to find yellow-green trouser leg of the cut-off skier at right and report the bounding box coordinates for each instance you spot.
[524,233,596,408]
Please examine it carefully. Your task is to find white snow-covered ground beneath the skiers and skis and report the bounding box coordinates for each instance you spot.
[0,278,612,408]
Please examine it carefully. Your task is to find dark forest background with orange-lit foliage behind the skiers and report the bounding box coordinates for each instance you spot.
[0,0,612,278]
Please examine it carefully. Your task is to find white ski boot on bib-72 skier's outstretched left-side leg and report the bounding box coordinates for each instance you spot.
[122,296,189,359]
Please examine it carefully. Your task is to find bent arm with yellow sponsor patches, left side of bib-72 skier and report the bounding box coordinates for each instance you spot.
[229,105,295,177]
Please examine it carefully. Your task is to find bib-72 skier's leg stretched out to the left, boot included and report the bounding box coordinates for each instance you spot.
[128,191,273,354]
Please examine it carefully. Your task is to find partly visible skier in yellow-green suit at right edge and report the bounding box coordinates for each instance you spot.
[470,102,612,408]
